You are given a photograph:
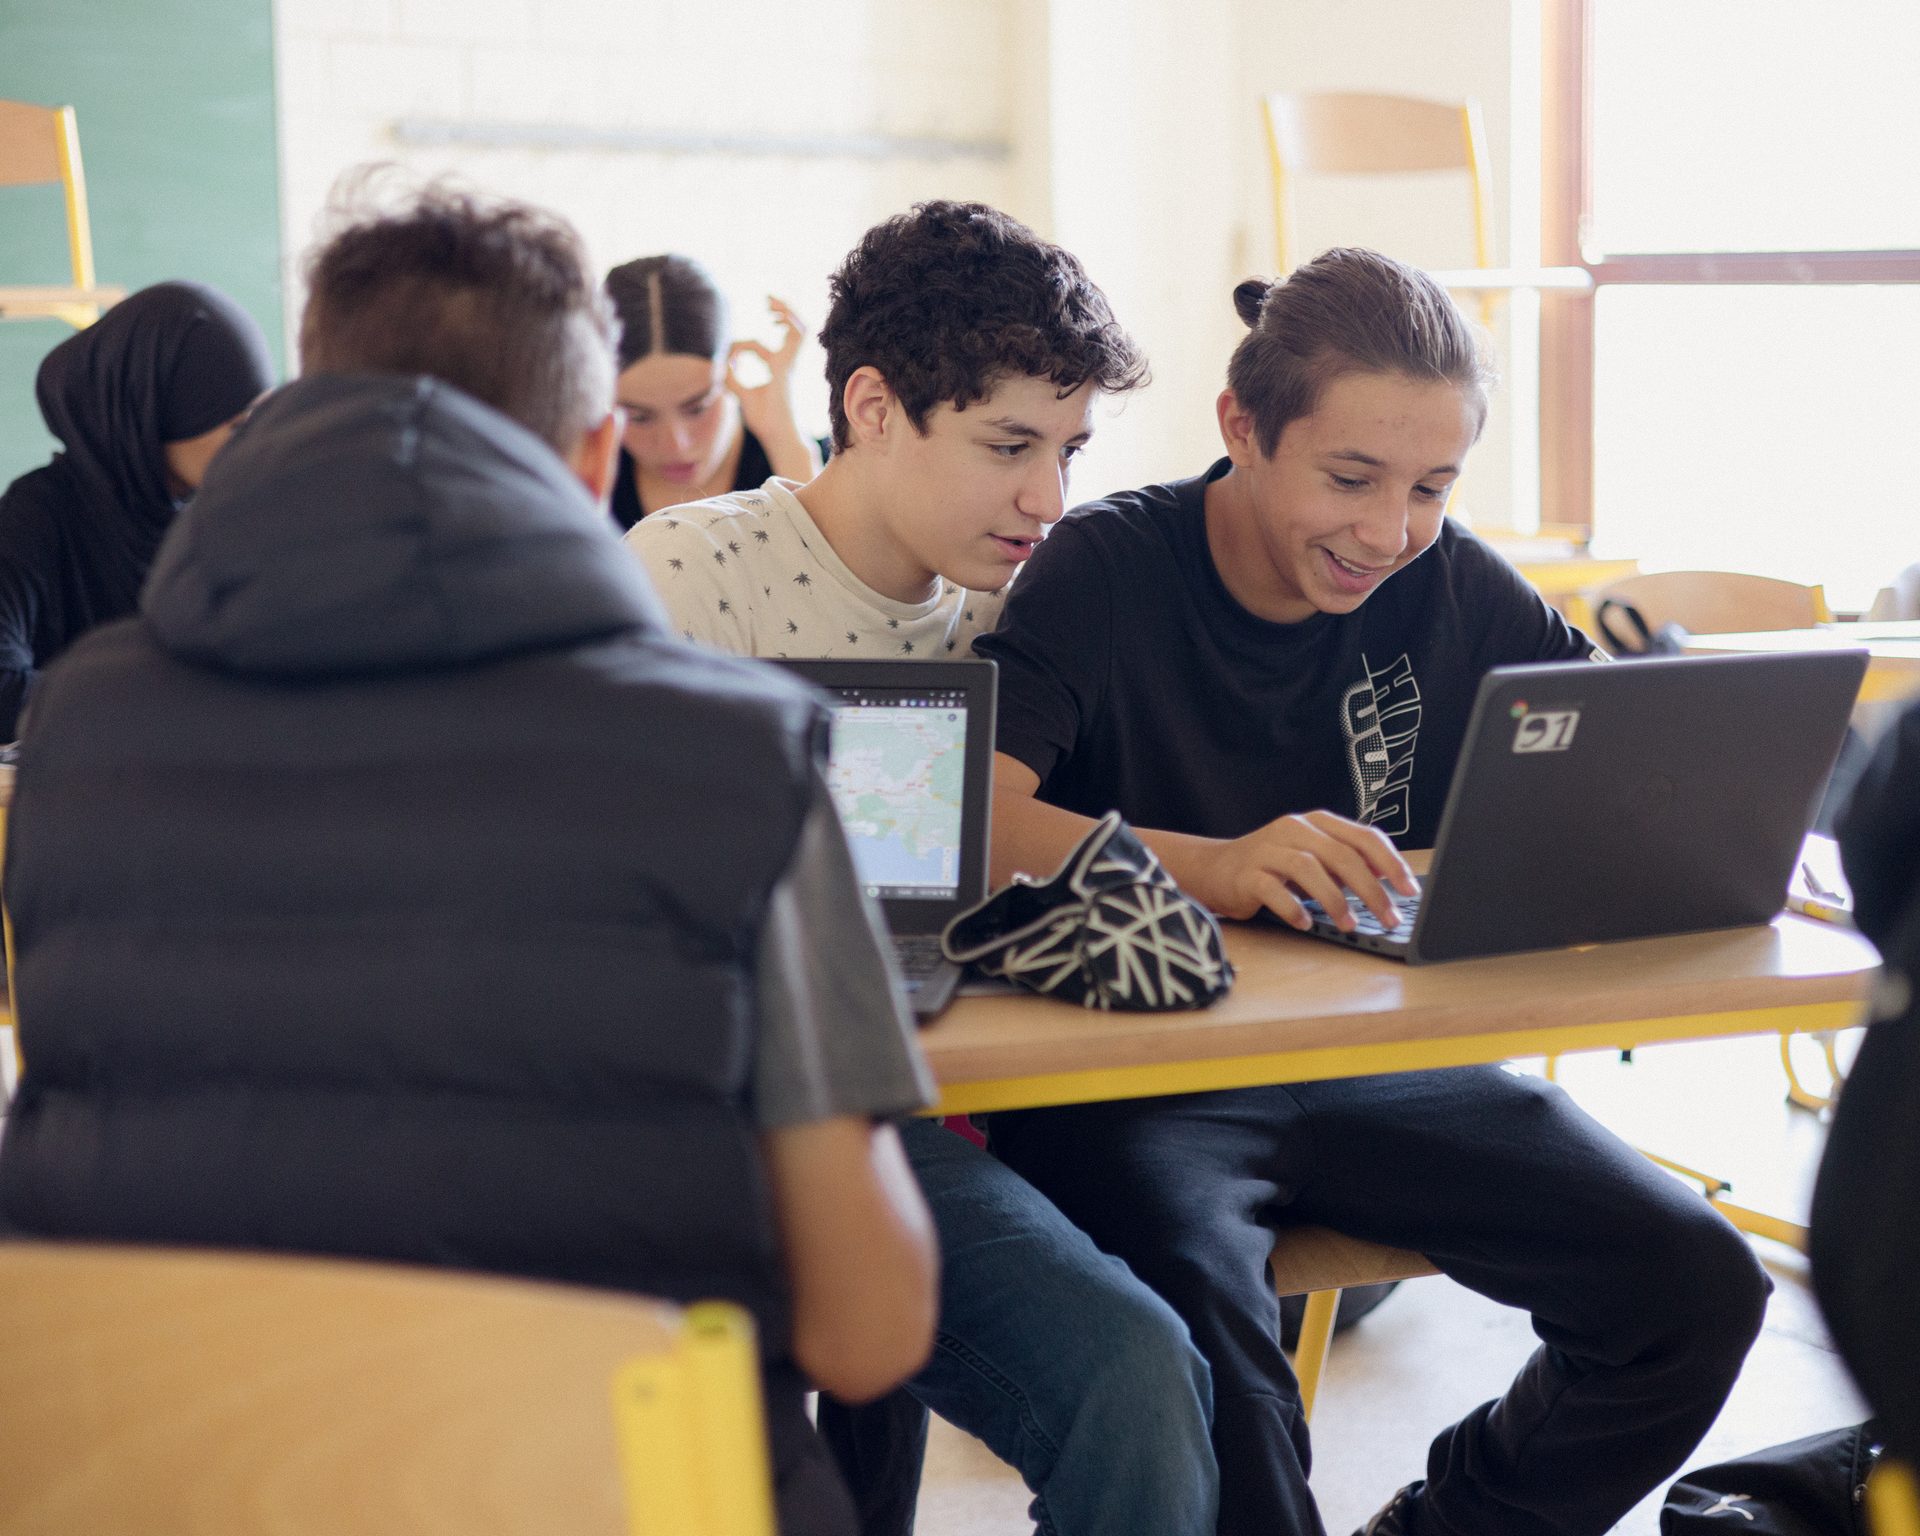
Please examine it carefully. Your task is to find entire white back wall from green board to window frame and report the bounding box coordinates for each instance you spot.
[276,0,1511,522]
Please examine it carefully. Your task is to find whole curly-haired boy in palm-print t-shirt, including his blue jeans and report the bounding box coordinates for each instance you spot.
[626,202,1219,1536]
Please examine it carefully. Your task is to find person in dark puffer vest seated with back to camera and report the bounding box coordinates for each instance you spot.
[0,192,935,1534]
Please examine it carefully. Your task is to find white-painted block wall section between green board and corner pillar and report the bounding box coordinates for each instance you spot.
[275,0,1044,432]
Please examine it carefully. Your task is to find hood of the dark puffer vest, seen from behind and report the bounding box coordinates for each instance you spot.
[140,374,666,678]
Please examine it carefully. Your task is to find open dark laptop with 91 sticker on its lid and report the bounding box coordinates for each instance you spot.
[1308,651,1866,964]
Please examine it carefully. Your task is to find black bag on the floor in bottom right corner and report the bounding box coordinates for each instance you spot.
[1661,1421,1880,1536]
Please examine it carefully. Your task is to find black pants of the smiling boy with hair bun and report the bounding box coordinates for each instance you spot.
[991,1068,1770,1536]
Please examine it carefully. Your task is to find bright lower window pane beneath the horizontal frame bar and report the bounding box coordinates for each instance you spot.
[1594,286,1920,609]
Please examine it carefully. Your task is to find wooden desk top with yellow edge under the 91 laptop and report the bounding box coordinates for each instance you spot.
[920,916,1878,1114]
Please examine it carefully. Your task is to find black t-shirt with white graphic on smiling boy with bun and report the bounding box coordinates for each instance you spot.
[973,459,1594,849]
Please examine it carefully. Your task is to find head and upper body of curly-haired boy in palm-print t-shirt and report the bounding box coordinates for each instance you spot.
[626,204,1146,659]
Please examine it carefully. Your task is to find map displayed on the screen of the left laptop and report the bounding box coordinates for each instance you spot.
[828,689,966,900]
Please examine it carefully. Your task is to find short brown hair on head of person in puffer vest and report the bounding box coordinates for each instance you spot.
[300,167,616,453]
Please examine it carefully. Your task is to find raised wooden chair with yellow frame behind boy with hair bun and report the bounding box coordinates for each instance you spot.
[1261,90,1494,324]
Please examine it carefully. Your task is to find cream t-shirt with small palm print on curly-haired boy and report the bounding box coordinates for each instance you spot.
[626,476,1006,660]
